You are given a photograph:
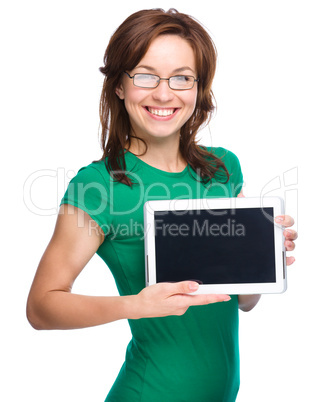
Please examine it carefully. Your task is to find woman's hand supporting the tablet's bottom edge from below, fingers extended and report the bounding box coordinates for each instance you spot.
[133,281,231,319]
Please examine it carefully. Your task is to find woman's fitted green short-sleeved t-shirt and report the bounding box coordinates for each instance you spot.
[61,148,243,402]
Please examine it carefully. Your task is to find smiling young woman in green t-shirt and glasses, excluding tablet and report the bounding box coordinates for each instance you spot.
[27,9,297,402]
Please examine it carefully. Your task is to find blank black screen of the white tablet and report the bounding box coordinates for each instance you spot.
[154,208,276,285]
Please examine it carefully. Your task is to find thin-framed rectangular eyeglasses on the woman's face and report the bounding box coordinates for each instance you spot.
[124,71,199,91]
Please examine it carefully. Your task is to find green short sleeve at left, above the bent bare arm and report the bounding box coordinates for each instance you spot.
[60,164,111,234]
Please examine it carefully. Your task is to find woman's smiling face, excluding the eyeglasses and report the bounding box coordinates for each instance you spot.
[116,35,198,143]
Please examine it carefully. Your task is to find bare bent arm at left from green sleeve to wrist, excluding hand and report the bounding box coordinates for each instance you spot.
[27,205,133,329]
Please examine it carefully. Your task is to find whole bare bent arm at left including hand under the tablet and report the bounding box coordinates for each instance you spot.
[27,205,230,329]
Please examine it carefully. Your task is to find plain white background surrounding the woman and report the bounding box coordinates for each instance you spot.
[0,0,320,402]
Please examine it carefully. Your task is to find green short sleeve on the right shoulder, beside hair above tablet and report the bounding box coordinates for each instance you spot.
[208,147,243,197]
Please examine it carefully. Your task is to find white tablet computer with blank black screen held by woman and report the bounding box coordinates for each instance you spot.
[144,197,287,294]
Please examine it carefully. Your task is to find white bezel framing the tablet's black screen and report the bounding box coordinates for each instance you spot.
[144,197,287,294]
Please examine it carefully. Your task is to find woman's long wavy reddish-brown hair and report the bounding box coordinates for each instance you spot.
[96,9,229,185]
